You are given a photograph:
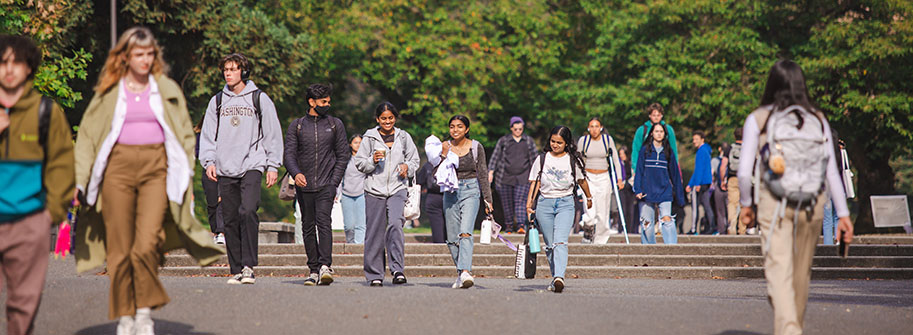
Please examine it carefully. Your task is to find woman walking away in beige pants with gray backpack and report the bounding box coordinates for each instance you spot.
[738,60,853,335]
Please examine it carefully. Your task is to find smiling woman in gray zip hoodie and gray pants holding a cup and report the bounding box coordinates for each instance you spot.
[354,101,419,286]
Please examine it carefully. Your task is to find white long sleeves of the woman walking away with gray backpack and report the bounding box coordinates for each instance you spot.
[738,107,850,217]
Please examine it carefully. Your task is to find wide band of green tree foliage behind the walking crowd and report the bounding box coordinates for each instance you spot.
[0,0,913,232]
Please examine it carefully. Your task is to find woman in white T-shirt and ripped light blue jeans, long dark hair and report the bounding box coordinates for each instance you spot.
[526,126,593,293]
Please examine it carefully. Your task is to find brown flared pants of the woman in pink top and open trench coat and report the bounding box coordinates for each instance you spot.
[101,144,168,319]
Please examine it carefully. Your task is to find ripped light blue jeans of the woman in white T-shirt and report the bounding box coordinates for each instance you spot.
[536,195,574,278]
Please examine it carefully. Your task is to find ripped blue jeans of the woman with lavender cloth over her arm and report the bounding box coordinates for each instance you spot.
[444,178,482,272]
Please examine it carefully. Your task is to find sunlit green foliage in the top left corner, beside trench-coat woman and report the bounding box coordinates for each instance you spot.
[0,0,92,108]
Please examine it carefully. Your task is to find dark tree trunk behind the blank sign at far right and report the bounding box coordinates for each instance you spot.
[847,143,897,234]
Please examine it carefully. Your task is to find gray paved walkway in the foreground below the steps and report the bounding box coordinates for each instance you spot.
[7,258,913,335]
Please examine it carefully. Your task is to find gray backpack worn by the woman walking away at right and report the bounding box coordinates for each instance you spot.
[760,105,829,206]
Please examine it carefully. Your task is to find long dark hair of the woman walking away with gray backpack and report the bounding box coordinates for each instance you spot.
[761,59,824,133]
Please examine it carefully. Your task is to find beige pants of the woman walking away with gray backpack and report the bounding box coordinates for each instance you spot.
[758,187,827,334]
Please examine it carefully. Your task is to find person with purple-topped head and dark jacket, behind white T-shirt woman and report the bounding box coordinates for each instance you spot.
[488,116,538,234]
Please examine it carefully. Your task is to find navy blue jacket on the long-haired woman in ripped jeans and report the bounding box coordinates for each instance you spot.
[634,143,685,206]
